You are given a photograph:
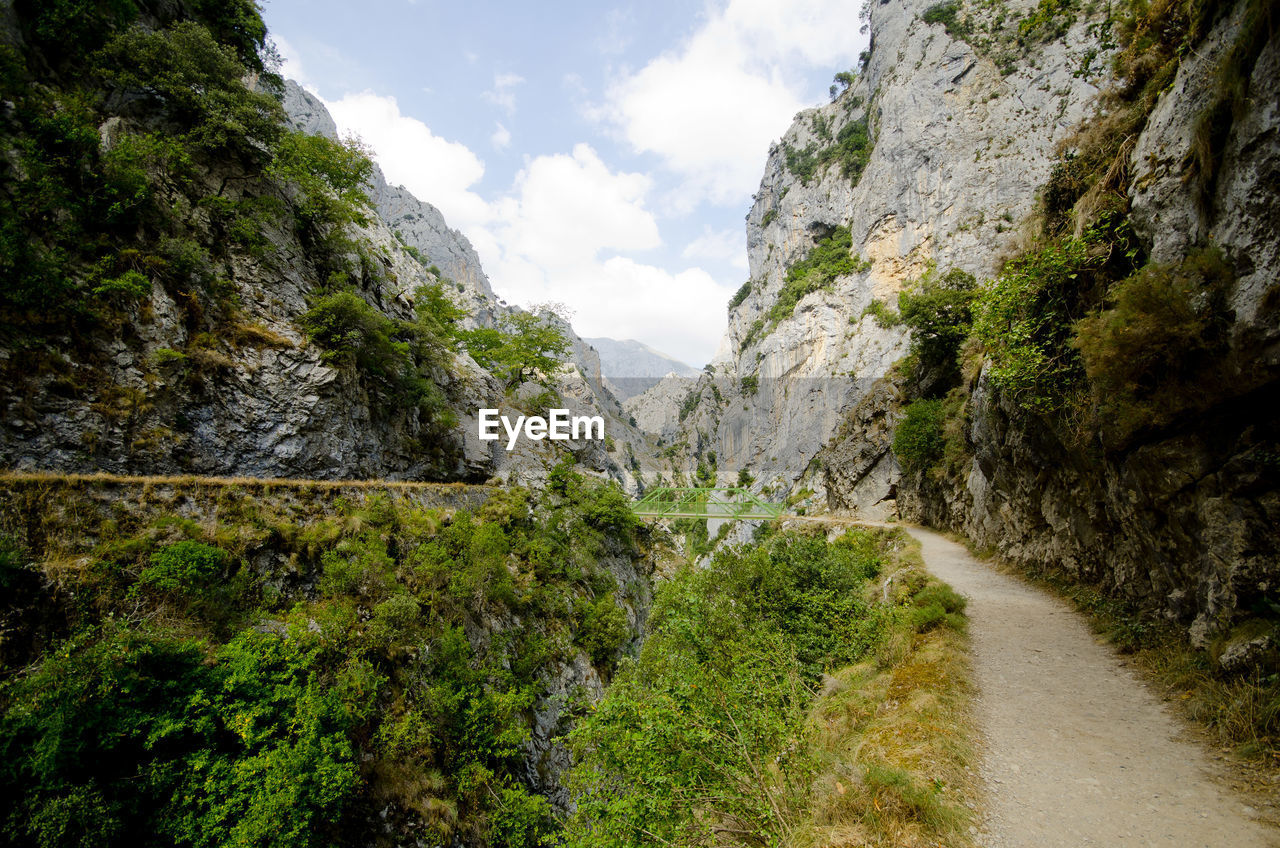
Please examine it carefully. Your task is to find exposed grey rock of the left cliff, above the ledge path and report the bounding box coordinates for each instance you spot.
[0,82,644,489]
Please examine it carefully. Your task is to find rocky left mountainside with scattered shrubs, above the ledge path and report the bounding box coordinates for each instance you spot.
[0,16,644,488]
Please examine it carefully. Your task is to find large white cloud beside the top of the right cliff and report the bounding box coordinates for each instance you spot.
[595,0,865,204]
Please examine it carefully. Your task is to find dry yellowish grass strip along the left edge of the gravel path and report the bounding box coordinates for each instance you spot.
[788,530,975,848]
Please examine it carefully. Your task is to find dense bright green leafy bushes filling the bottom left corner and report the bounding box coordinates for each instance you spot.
[0,625,379,848]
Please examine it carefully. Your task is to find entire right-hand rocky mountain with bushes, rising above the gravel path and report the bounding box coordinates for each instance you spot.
[665,0,1280,648]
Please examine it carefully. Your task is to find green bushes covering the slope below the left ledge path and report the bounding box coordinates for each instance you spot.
[0,481,650,848]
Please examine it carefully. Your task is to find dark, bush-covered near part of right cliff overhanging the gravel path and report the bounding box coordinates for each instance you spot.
[893,0,1280,753]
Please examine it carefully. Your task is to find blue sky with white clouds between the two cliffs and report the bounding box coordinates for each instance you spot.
[262,0,867,366]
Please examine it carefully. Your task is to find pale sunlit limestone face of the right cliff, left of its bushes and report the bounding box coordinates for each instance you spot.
[684,0,1101,503]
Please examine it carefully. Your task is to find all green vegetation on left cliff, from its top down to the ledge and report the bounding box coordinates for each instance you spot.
[0,0,483,475]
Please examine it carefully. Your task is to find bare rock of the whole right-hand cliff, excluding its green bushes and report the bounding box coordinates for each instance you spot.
[680,0,1280,650]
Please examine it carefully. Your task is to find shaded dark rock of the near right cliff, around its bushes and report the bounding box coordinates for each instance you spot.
[902,4,1280,648]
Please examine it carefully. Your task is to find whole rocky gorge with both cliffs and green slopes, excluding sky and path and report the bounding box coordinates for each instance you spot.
[0,0,1280,848]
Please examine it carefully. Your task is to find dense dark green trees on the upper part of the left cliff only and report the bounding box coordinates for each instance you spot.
[0,0,380,356]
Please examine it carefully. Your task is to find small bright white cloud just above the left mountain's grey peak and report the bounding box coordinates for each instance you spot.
[325,91,490,231]
